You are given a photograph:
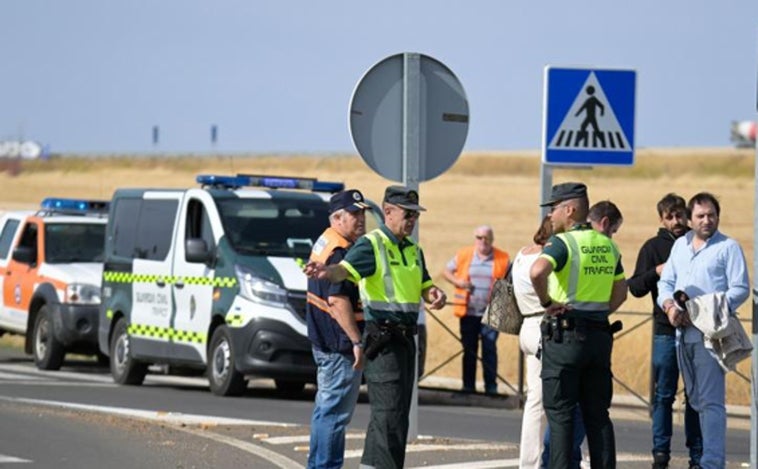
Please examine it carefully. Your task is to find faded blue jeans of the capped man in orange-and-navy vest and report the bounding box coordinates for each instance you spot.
[308,347,361,469]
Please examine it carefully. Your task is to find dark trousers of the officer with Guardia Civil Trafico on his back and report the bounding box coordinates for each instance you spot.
[542,329,616,469]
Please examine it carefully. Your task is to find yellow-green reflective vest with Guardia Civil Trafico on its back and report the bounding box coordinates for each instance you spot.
[548,229,621,313]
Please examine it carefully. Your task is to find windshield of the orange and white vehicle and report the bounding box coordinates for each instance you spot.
[45,223,105,264]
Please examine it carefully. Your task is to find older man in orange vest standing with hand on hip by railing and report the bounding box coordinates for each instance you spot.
[443,225,510,395]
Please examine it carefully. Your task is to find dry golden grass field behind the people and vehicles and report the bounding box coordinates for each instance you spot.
[0,148,755,405]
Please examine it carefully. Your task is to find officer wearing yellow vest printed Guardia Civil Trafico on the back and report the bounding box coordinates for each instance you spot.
[530,182,626,469]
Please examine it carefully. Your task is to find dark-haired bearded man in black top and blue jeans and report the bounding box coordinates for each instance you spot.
[628,193,703,469]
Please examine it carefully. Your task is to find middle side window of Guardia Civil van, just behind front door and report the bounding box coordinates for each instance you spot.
[134,200,179,261]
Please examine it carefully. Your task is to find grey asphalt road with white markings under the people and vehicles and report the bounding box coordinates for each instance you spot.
[0,349,750,469]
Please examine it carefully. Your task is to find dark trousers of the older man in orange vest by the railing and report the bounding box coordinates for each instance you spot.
[461,316,498,393]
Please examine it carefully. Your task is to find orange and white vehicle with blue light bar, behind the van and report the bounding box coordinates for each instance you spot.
[0,198,108,370]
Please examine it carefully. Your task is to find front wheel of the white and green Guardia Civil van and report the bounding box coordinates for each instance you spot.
[208,326,247,396]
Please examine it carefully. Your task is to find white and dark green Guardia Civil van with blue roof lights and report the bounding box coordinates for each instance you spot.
[98,175,386,396]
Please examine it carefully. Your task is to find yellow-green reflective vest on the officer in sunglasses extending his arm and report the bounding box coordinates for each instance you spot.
[360,229,423,317]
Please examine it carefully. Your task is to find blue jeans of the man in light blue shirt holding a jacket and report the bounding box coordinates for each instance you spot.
[677,334,726,469]
